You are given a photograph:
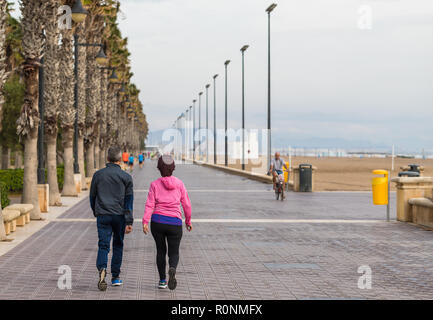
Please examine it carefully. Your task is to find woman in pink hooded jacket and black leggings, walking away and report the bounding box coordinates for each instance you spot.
[143,155,192,290]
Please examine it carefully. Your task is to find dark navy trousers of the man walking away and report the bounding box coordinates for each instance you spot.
[96,215,126,278]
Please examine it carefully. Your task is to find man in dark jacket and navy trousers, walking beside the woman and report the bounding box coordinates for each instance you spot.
[90,147,134,291]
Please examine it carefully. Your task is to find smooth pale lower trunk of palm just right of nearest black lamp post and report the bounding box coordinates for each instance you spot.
[46,133,62,206]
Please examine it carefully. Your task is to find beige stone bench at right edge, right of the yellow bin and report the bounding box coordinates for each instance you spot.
[391,177,433,222]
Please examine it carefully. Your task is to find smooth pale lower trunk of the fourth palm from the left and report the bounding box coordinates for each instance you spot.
[62,128,78,197]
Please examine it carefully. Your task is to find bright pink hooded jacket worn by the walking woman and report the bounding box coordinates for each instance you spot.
[143,176,191,225]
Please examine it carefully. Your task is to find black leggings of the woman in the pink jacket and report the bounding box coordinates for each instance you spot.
[151,221,182,280]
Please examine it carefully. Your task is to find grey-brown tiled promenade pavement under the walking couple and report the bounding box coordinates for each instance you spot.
[0,163,433,299]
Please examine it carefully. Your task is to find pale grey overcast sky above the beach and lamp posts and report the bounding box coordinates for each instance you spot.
[11,0,433,149]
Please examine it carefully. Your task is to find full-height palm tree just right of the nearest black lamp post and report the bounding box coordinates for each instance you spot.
[44,0,62,206]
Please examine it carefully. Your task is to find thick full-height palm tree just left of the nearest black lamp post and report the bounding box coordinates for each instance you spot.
[17,0,45,220]
